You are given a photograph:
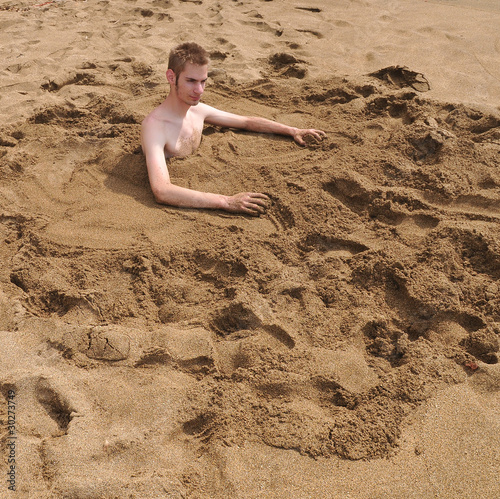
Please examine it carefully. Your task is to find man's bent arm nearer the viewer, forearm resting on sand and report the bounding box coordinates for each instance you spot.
[141,119,269,215]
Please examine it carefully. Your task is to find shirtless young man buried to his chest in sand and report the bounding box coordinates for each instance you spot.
[141,43,325,215]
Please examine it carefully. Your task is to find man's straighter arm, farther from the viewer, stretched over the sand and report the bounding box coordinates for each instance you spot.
[201,105,326,146]
